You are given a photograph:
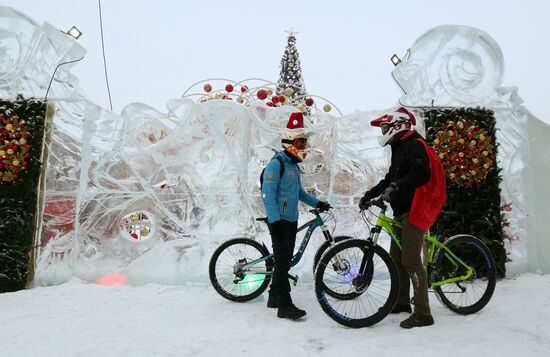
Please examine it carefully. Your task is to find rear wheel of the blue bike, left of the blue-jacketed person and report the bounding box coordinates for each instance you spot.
[208,238,273,302]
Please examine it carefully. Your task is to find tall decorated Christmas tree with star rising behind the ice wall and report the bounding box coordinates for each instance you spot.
[277,30,311,112]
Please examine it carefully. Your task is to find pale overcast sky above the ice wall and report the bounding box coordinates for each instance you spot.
[2,0,550,123]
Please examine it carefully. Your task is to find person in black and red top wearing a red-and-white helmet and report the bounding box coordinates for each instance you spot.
[359,107,445,328]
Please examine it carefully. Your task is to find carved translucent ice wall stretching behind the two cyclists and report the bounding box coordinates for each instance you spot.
[0,7,549,284]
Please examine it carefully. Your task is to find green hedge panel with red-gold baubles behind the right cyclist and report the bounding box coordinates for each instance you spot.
[424,108,507,277]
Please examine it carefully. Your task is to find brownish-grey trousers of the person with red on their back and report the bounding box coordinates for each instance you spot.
[390,212,431,315]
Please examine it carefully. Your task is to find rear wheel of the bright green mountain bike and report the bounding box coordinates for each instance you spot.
[430,234,496,315]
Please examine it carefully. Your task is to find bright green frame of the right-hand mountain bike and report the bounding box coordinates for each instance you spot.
[361,203,474,288]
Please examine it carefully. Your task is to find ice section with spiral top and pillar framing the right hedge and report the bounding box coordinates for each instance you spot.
[392,25,550,275]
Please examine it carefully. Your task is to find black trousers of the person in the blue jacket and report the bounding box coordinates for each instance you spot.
[269,220,298,307]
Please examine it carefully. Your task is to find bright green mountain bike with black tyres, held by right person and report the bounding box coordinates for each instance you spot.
[315,199,496,328]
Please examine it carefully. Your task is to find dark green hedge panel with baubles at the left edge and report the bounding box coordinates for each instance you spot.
[0,96,46,293]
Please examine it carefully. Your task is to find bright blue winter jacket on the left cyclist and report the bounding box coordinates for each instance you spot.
[262,150,319,223]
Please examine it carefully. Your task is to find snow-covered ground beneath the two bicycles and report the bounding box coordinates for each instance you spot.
[0,274,550,357]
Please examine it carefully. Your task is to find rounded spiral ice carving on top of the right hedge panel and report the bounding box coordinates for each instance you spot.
[393,25,504,106]
